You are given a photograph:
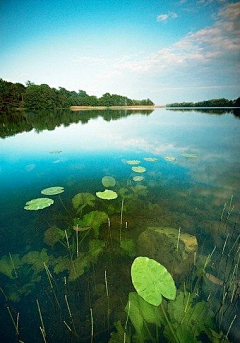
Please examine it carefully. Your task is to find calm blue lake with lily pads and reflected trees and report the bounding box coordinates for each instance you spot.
[0,109,240,343]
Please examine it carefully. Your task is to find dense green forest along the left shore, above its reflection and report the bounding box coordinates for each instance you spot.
[0,79,154,110]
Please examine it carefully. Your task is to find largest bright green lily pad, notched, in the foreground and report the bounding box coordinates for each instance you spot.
[131,257,176,306]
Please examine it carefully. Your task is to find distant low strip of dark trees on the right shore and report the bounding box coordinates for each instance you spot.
[166,97,240,107]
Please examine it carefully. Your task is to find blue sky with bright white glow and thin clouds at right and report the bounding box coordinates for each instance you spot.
[0,0,240,105]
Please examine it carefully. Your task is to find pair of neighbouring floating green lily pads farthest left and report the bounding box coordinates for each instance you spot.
[24,186,64,211]
